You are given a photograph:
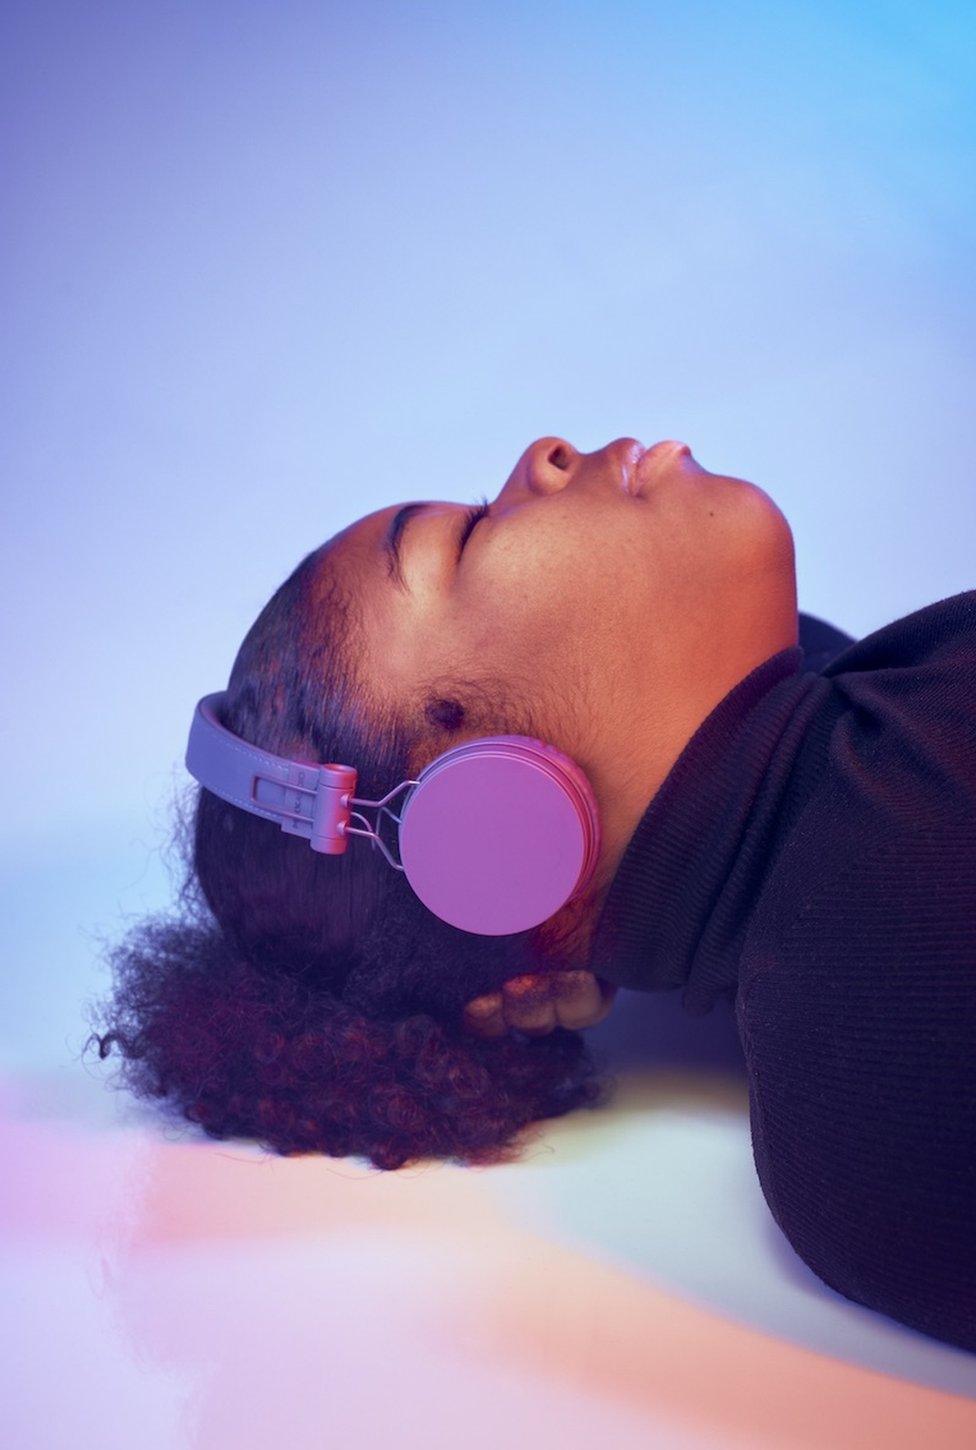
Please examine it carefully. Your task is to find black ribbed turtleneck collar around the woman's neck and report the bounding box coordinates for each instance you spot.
[589,645,834,1016]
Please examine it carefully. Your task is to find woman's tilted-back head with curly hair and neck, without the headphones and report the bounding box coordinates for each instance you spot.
[85,426,796,1167]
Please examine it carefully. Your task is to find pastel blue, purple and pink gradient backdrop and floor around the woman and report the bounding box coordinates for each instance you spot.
[0,0,976,1450]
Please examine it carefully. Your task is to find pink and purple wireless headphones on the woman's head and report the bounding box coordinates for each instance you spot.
[186,690,600,937]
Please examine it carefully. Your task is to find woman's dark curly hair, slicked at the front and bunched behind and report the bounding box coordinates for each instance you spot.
[84,533,613,1169]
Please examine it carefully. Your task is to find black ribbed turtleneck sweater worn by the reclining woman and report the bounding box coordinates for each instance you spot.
[590,590,976,1351]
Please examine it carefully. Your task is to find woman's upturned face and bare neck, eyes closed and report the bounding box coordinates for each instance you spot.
[328,438,798,957]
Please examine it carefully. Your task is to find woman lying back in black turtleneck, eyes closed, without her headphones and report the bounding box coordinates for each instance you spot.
[87,438,976,1349]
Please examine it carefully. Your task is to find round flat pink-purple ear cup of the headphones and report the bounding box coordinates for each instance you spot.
[399,735,600,937]
